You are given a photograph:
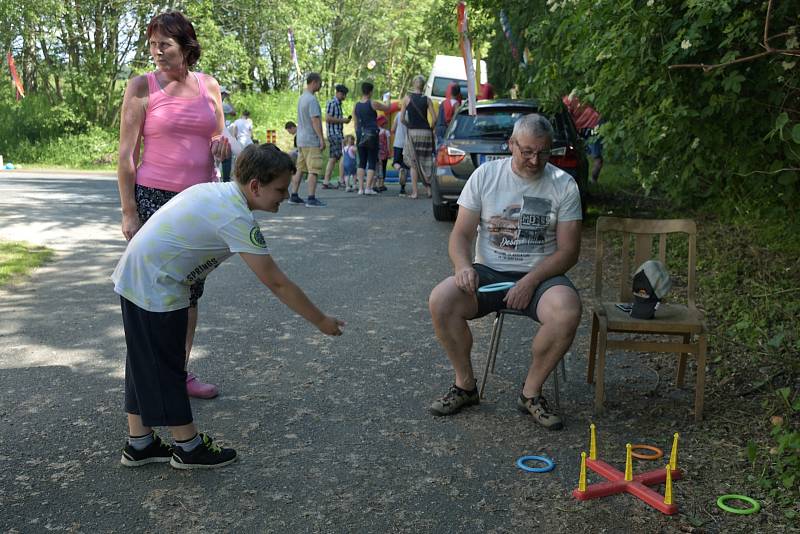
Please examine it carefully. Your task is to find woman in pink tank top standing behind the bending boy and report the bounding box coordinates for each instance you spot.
[117,11,230,402]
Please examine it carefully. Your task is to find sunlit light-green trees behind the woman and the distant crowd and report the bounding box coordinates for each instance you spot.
[0,0,455,139]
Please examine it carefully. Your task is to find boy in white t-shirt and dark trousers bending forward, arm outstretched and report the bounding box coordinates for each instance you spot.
[111,145,344,469]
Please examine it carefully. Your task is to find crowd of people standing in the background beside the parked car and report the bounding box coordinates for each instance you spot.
[212,72,506,207]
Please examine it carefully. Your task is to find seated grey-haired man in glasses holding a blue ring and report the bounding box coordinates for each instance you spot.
[429,114,581,430]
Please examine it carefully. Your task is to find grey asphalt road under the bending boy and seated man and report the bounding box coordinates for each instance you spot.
[0,172,732,534]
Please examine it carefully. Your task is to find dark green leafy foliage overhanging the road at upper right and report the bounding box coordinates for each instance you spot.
[476,0,800,207]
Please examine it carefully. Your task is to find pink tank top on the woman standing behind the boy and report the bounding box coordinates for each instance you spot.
[136,72,217,192]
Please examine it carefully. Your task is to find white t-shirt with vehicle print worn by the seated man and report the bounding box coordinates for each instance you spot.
[458,158,581,272]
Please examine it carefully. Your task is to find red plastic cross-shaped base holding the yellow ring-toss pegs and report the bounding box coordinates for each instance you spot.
[572,458,682,515]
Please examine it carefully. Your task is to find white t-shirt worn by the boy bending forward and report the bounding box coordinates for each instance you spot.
[111,182,269,312]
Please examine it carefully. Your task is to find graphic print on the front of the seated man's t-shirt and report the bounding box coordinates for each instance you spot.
[487,196,553,254]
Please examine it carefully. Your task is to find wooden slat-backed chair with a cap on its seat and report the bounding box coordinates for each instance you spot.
[587,217,706,421]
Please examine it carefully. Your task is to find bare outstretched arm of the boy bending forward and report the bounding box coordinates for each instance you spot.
[239,252,344,336]
